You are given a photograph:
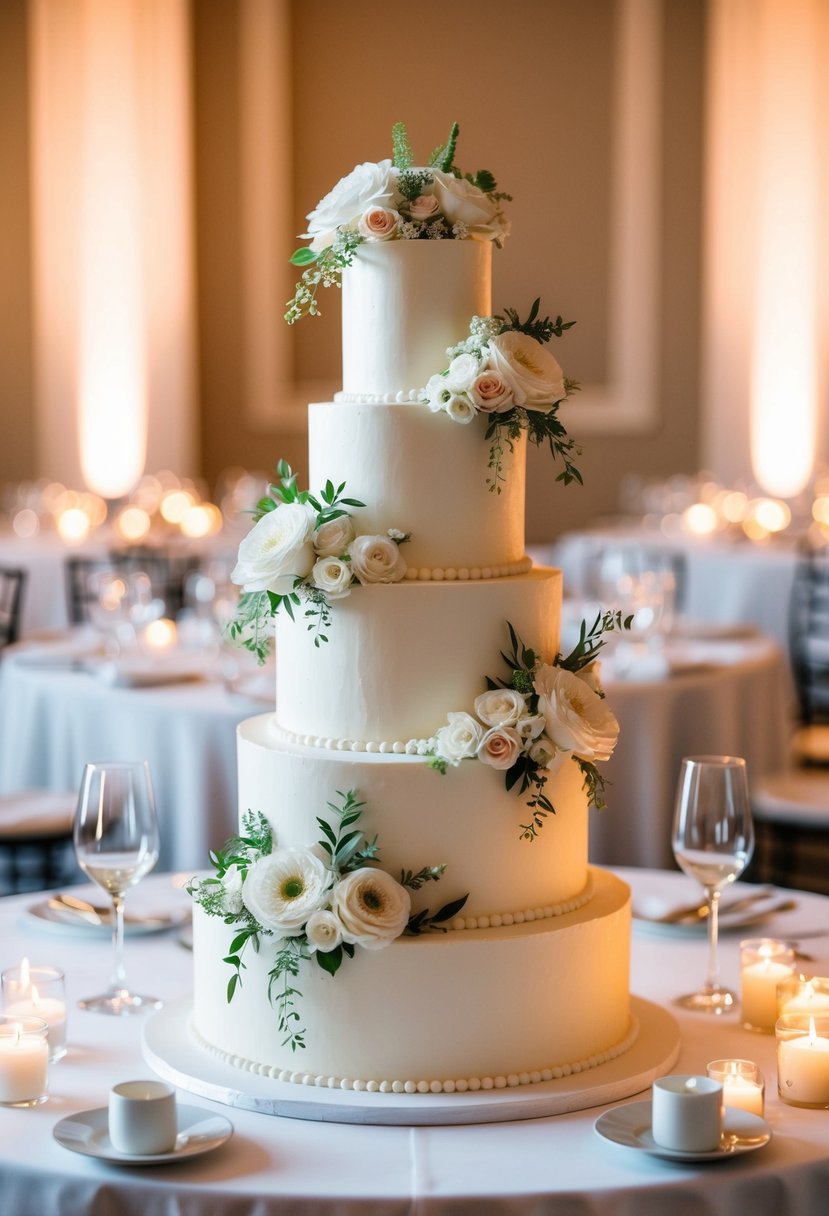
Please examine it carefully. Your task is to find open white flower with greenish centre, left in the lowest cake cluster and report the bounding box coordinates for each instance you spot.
[242,849,332,938]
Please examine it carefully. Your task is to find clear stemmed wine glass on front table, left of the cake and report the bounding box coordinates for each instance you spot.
[73,760,160,1015]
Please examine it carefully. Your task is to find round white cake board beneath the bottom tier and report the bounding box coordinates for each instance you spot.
[142,997,679,1126]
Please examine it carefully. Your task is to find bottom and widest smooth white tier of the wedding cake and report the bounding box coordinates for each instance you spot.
[193,871,631,1085]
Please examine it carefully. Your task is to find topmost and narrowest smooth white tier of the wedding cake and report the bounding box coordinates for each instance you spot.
[343,233,492,395]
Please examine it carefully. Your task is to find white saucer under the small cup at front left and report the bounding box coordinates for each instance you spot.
[53,1105,233,1165]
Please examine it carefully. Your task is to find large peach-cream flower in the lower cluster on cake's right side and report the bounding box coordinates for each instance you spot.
[535,665,619,762]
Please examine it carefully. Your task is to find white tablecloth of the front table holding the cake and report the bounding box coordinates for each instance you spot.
[0,871,829,1216]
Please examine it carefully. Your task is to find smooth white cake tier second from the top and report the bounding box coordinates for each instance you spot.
[309,398,526,578]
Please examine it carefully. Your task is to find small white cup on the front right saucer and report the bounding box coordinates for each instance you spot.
[650,1076,722,1153]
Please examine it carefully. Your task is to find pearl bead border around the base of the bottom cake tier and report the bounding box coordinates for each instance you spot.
[190,1015,639,1093]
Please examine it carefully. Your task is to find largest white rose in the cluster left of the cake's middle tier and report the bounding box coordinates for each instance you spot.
[231,502,316,596]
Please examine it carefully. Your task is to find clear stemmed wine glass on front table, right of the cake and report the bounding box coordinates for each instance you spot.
[671,756,754,1013]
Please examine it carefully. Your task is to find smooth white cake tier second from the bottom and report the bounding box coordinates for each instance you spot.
[237,714,587,919]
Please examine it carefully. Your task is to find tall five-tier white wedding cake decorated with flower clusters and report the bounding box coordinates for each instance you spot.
[192,126,635,1092]
